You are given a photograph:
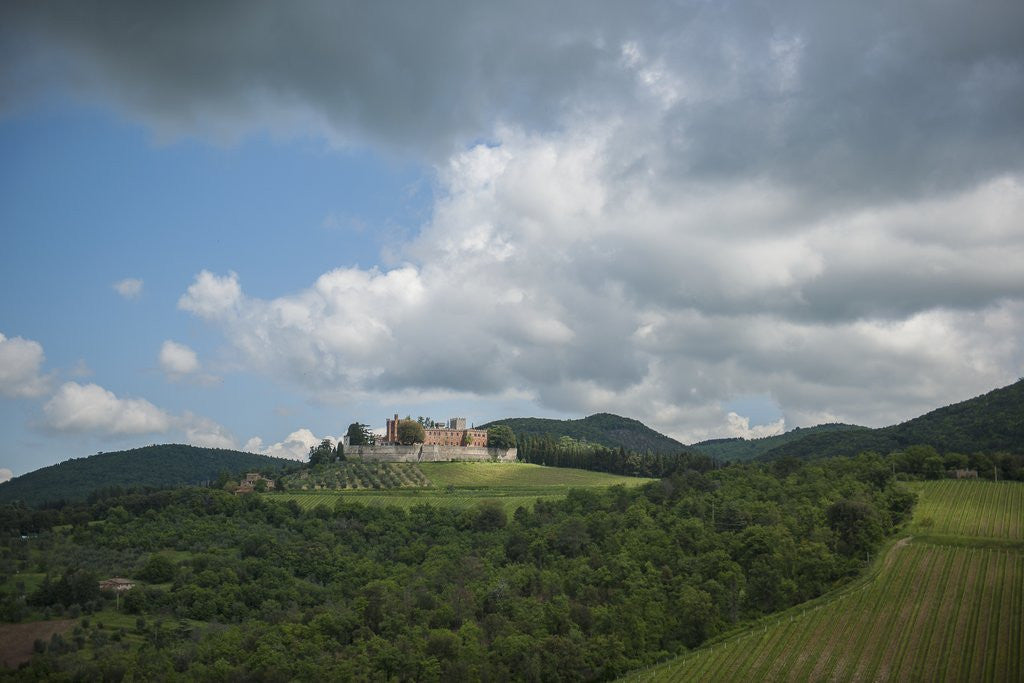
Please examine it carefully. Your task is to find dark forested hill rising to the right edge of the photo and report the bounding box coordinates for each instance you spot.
[763,380,1024,459]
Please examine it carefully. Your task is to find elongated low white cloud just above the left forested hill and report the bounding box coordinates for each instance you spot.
[43,382,172,435]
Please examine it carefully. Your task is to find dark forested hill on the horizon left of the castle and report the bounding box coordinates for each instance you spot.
[0,443,296,505]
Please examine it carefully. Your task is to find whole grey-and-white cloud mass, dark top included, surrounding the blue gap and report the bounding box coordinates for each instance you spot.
[0,0,1024,440]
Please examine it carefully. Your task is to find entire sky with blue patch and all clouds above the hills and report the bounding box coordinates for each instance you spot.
[0,0,1024,480]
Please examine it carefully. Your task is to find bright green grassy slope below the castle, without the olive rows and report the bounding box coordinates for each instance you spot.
[264,463,651,512]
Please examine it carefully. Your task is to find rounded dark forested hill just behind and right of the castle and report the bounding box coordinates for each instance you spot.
[480,413,686,454]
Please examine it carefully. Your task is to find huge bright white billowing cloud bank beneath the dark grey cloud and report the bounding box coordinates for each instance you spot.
[181,123,1024,442]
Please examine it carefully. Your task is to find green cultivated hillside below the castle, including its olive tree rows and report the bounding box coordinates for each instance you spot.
[264,463,650,512]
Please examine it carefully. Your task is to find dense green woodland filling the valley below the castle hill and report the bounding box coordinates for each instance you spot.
[0,456,912,681]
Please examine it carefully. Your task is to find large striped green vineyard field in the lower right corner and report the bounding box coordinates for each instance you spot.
[630,481,1024,681]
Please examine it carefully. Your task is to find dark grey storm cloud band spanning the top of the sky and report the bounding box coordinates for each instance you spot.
[2,0,1024,192]
